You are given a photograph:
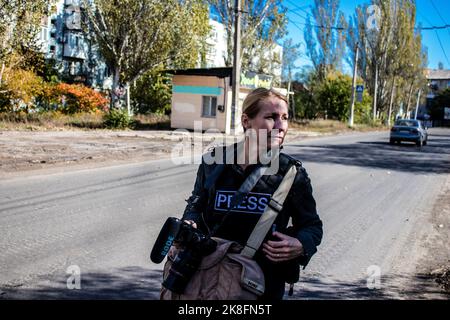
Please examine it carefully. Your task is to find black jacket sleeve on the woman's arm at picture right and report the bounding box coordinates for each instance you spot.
[288,165,323,268]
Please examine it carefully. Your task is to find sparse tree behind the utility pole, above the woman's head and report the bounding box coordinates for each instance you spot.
[208,0,287,74]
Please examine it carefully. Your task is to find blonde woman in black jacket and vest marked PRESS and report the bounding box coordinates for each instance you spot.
[183,88,322,300]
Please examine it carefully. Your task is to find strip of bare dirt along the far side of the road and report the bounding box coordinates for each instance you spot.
[0,130,326,179]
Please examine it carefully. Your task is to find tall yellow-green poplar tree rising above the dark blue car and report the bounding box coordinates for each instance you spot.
[347,0,427,119]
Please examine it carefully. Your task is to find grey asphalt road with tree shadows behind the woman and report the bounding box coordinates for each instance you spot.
[0,129,450,299]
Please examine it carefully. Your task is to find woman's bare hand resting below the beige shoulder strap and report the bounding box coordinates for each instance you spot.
[263,231,303,262]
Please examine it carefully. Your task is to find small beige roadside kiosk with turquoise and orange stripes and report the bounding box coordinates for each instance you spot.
[170,68,287,134]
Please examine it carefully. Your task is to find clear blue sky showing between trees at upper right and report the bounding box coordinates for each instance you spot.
[283,0,450,69]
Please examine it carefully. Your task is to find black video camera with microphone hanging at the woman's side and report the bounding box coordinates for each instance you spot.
[150,217,217,294]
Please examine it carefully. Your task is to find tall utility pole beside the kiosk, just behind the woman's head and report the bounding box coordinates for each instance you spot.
[231,0,241,134]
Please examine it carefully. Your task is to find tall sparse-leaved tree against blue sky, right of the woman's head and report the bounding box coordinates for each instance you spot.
[304,0,347,80]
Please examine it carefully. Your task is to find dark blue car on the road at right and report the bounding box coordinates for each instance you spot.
[389,119,428,147]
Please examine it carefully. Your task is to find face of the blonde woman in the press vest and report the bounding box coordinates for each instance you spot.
[242,96,288,148]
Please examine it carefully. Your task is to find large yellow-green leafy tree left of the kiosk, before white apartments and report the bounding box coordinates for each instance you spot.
[84,0,209,107]
